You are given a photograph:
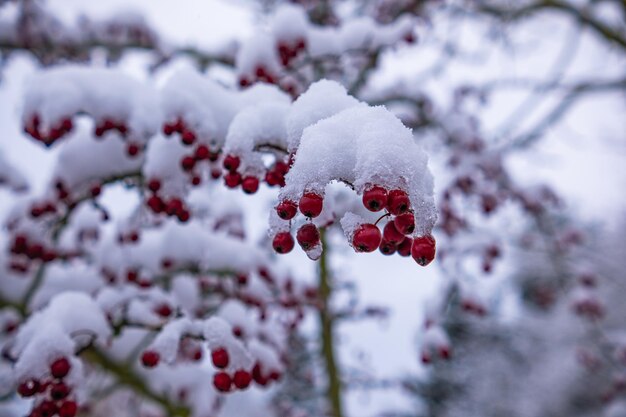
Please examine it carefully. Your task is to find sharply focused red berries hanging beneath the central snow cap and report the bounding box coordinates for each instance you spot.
[272,186,435,266]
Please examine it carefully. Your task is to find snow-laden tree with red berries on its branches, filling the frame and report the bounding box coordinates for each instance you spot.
[0,0,626,417]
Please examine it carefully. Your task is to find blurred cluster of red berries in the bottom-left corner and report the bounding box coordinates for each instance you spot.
[17,357,78,417]
